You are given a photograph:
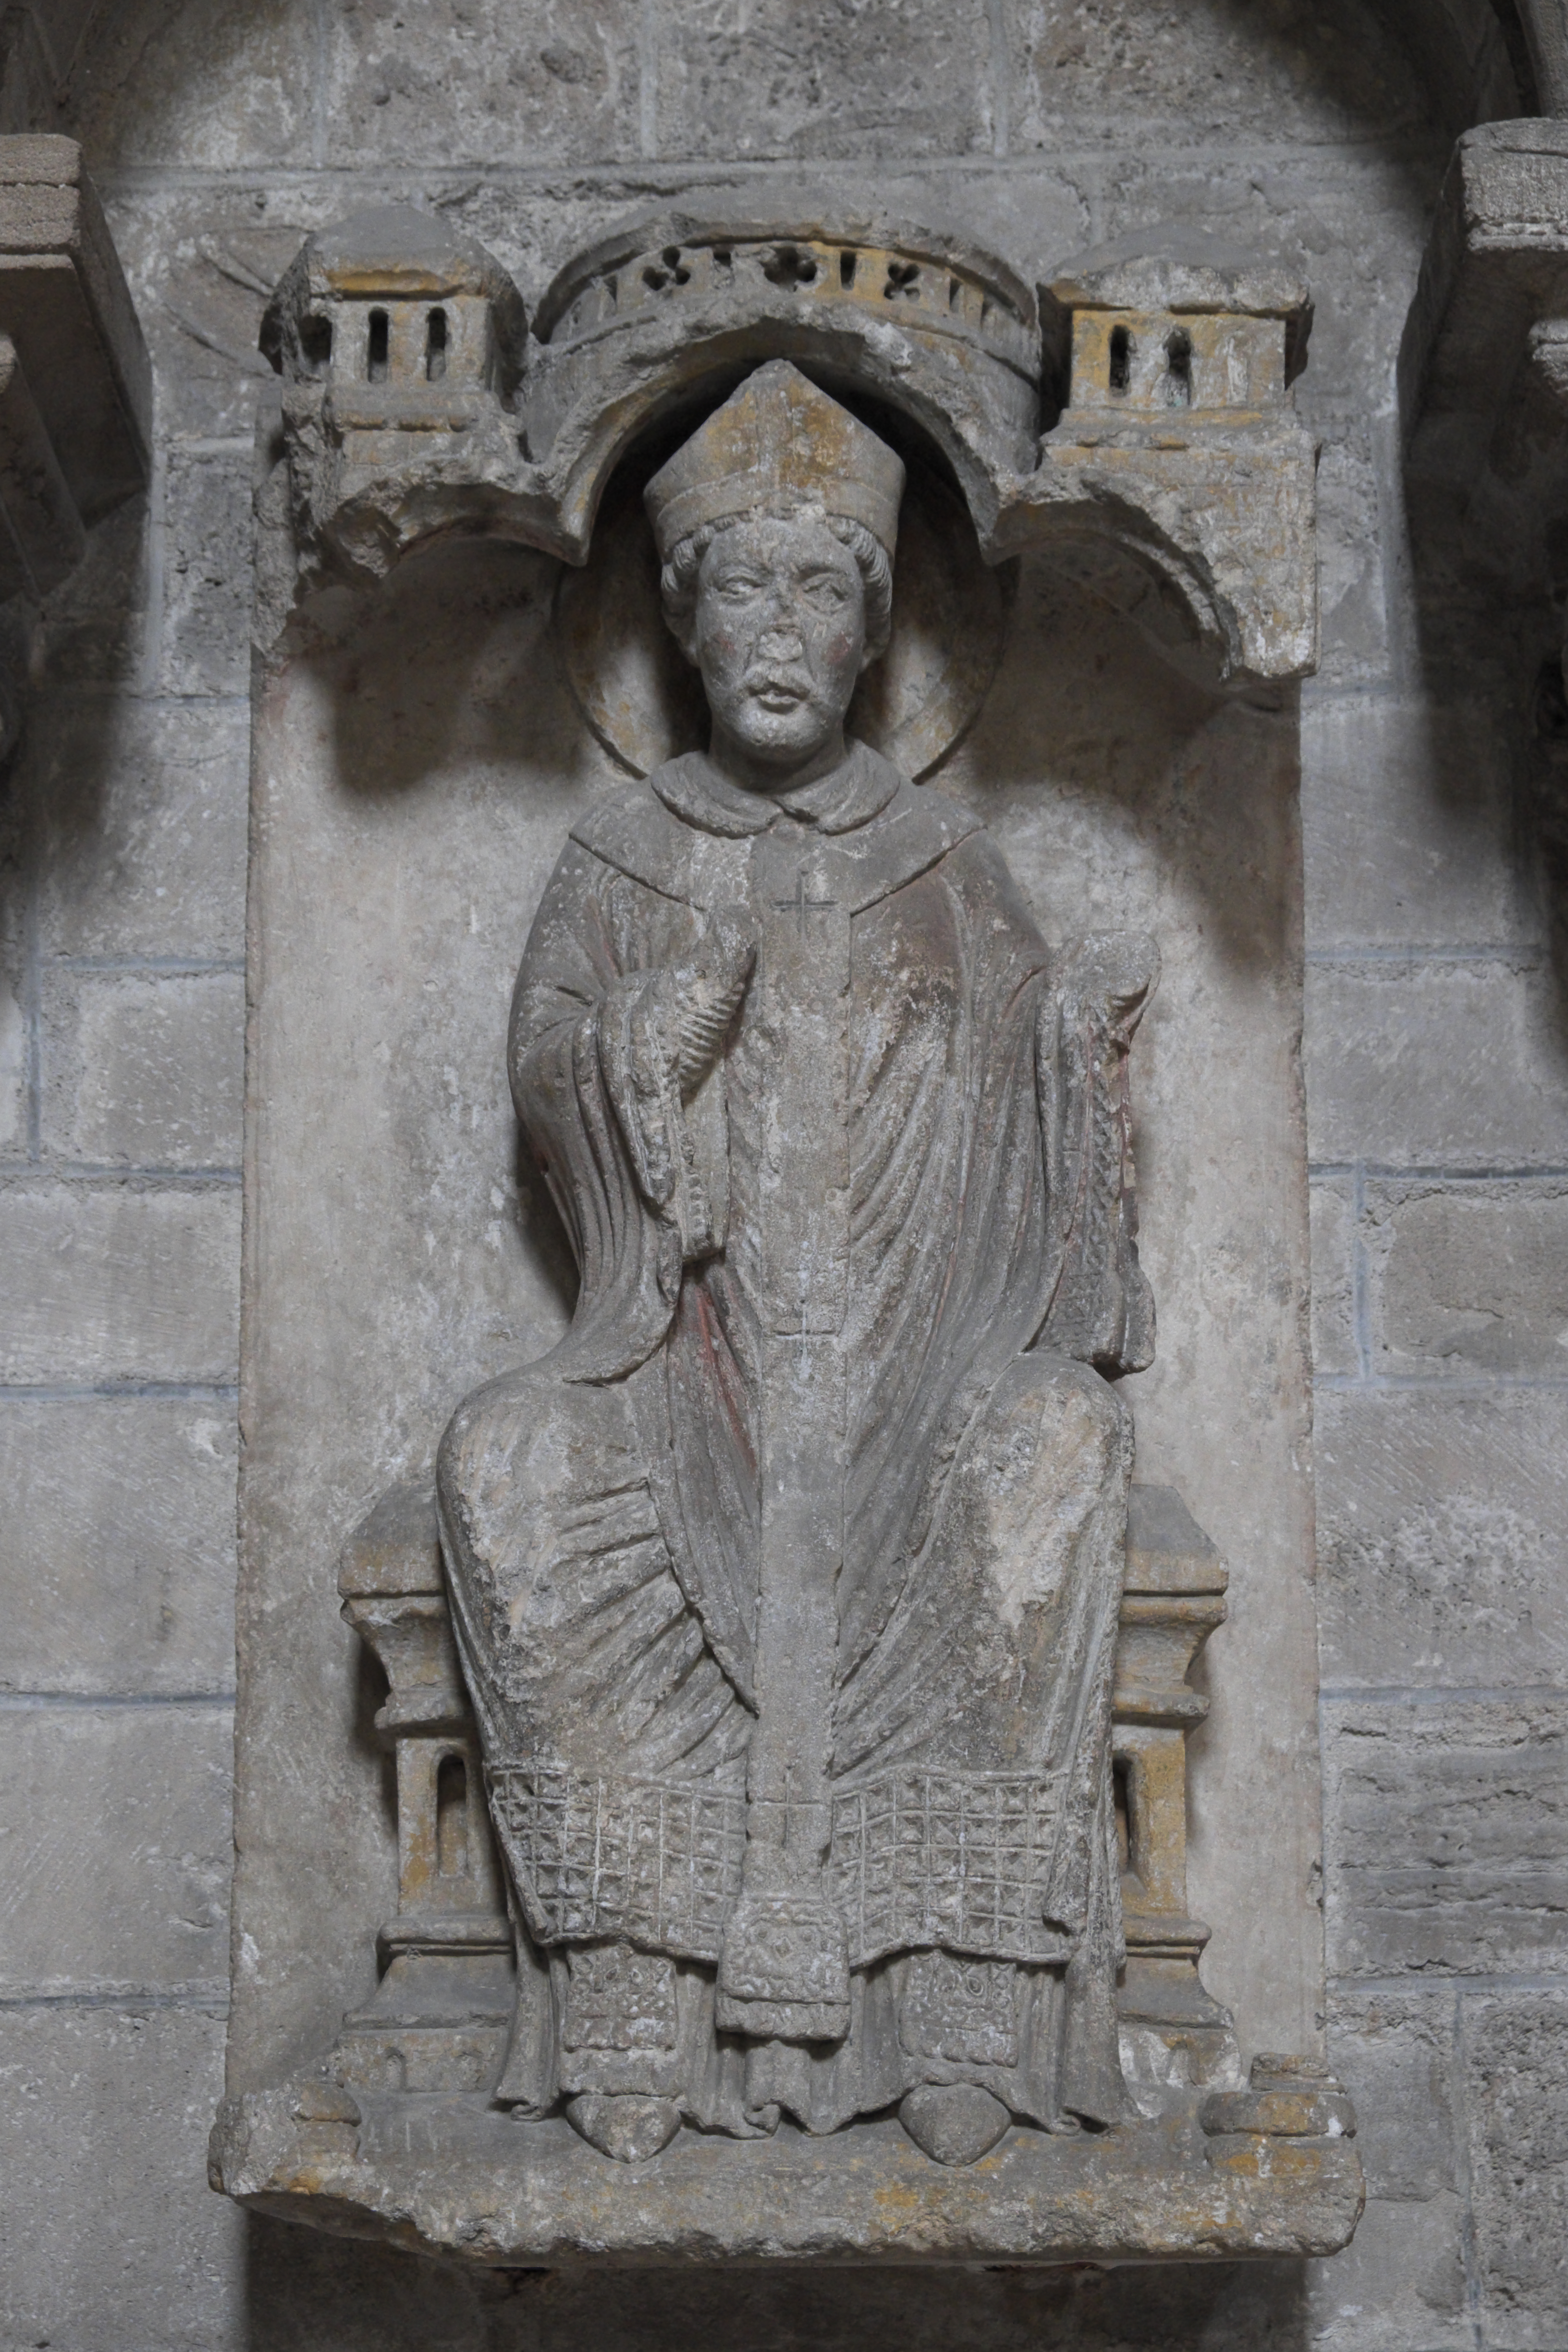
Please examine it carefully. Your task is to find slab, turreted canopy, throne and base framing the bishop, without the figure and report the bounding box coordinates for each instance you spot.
[211,200,1361,2265]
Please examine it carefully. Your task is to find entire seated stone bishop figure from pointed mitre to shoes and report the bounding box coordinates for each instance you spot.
[437,362,1154,2161]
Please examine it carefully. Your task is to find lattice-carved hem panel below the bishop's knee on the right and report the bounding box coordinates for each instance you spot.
[830,1771,1063,1969]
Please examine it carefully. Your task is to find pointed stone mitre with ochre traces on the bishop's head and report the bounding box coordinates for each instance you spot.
[644,360,903,562]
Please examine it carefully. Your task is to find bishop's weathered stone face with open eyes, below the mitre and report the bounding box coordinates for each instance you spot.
[691,520,865,769]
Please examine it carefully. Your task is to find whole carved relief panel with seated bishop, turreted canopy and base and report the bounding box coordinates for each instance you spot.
[211,211,1363,2267]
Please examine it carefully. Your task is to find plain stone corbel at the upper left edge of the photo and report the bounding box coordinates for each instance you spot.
[0,134,153,760]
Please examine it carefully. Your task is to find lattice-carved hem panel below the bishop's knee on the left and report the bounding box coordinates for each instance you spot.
[484,1762,745,1961]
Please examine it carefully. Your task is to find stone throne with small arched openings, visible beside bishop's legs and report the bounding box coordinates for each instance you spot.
[327,1480,1244,2112]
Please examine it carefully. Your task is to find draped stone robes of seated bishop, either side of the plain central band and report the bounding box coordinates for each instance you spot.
[442,746,1154,2131]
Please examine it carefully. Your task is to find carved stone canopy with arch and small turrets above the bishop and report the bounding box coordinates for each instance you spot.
[263,205,1316,680]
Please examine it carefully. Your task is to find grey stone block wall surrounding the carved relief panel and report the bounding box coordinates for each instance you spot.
[0,0,1568,2352]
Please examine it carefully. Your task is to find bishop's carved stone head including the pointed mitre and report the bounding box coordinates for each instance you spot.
[647,360,903,772]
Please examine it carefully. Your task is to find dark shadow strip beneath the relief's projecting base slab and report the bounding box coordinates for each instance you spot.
[247,2216,1307,2352]
